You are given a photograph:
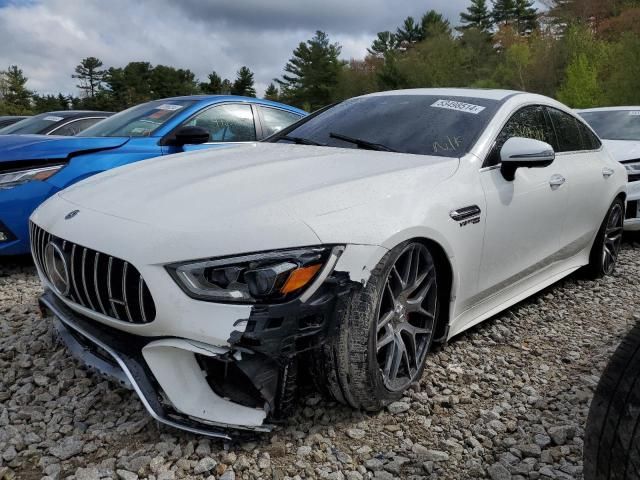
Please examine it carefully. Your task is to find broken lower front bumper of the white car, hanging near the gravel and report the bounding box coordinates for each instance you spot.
[40,291,271,440]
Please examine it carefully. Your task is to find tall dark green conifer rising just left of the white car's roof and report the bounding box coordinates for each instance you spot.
[276,31,343,110]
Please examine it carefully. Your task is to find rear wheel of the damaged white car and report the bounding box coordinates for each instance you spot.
[586,198,624,279]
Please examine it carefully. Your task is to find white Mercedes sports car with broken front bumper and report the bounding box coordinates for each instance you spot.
[31,89,627,436]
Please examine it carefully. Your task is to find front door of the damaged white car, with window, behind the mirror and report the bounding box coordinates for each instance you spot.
[478,105,569,298]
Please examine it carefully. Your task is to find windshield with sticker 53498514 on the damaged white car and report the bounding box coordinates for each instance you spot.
[270,95,500,157]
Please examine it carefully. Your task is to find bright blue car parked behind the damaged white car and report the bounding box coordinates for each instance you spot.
[0,95,306,255]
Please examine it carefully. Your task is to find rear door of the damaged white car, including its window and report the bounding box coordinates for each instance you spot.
[547,107,613,253]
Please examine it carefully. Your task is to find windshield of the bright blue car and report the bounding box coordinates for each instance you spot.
[78,100,196,137]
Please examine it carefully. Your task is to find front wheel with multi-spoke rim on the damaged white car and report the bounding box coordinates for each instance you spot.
[316,242,439,411]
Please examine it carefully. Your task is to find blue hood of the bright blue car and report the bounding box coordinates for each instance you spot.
[0,135,129,165]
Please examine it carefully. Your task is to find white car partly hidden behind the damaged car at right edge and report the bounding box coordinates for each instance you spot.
[578,107,640,231]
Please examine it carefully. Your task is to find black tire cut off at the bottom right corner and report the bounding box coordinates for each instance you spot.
[584,323,640,480]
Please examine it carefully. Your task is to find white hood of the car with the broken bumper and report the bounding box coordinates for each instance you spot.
[60,143,458,231]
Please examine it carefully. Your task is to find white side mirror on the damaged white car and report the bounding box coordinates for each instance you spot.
[500,137,556,181]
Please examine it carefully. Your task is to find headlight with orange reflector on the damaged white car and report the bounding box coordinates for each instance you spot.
[166,246,344,303]
